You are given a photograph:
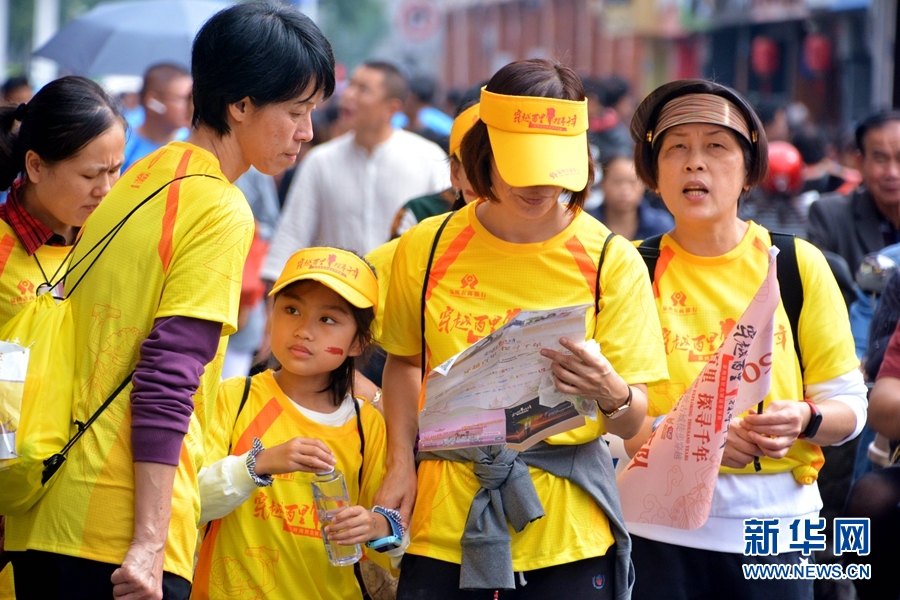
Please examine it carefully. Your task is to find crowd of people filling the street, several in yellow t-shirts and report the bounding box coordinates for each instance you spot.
[0,3,900,600]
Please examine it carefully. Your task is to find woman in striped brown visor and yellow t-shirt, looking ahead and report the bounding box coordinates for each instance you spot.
[626,80,866,600]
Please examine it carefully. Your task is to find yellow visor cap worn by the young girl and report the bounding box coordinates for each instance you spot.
[269,248,378,308]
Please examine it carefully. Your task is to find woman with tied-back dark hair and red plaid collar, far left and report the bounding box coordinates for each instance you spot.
[0,77,125,598]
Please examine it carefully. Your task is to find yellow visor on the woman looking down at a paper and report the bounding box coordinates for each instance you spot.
[478,88,590,192]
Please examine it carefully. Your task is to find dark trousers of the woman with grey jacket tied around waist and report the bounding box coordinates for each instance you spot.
[397,547,616,600]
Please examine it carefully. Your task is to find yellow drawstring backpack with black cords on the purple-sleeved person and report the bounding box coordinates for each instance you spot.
[0,173,218,515]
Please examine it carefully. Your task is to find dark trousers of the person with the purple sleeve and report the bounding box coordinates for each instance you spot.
[8,550,191,600]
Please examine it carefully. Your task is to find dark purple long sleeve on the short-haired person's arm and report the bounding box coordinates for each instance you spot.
[131,317,222,466]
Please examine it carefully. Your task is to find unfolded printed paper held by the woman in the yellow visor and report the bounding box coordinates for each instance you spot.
[419,305,599,451]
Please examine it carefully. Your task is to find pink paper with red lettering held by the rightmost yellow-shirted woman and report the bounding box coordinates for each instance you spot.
[618,248,781,529]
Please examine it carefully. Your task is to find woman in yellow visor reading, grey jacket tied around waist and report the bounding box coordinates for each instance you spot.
[376,60,666,599]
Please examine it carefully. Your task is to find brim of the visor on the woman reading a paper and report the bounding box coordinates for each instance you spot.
[487,125,588,192]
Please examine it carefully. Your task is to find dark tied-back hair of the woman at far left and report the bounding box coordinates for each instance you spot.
[0,75,127,190]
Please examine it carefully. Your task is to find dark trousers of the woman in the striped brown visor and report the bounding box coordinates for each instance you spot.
[631,535,815,600]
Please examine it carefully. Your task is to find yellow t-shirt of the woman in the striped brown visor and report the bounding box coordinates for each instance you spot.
[648,222,859,483]
